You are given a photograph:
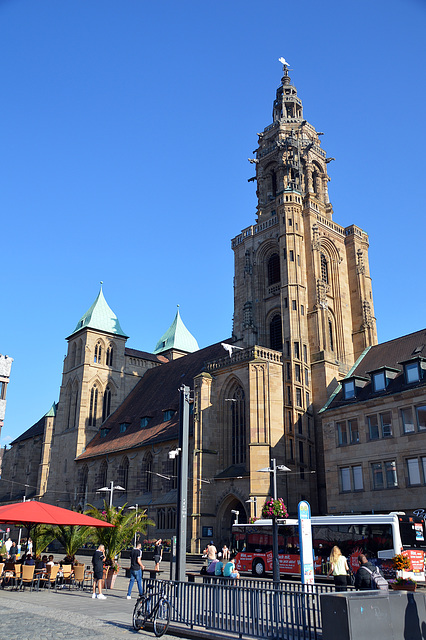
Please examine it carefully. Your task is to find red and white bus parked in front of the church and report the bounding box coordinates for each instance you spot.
[232,513,426,581]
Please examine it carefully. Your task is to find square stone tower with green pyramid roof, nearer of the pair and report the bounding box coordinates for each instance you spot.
[42,283,131,506]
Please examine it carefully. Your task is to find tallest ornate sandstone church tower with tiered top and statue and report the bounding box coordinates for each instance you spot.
[232,64,377,511]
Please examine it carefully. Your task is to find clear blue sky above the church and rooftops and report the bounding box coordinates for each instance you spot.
[0,0,426,444]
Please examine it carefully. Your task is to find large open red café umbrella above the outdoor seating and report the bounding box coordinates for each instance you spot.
[0,500,114,537]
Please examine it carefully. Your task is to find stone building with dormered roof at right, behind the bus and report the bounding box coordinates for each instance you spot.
[320,329,426,514]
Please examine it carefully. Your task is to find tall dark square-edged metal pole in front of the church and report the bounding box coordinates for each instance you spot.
[176,385,189,582]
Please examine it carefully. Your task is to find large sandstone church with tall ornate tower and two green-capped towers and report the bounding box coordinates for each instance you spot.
[2,66,377,551]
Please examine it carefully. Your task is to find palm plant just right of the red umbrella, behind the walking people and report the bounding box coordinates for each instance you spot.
[86,500,155,588]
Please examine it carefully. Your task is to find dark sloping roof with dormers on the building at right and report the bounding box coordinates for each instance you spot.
[321,329,426,411]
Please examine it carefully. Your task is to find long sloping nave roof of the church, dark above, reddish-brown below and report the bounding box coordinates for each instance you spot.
[77,342,230,461]
